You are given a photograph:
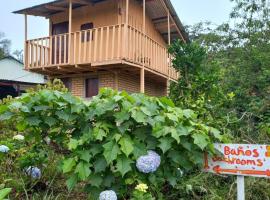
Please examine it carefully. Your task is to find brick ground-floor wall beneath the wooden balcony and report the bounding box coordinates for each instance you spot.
[66,72,167,97]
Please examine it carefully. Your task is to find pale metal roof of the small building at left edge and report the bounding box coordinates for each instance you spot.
[0,56,45,84]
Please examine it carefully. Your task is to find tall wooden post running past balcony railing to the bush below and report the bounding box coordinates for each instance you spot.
[140,0,146,93]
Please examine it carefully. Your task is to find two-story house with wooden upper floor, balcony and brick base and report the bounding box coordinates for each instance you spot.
[14,0,188,98]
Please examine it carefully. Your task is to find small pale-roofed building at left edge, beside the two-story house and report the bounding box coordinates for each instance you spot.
[0,56,45,99]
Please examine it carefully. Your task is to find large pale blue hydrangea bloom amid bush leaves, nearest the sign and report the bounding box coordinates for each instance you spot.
[136,150,160,174]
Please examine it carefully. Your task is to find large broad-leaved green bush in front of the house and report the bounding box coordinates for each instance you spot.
[0,88,223,198]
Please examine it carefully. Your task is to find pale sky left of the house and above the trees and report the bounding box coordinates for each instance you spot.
[0,0,233,52]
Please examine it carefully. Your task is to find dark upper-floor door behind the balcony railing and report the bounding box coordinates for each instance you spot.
[52,22,69,64]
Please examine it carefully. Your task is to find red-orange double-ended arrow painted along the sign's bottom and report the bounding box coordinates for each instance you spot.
[213,165,270,176]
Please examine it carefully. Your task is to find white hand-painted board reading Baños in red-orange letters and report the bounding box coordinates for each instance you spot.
[204,144,270,177]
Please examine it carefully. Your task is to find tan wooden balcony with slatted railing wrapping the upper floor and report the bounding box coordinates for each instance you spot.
[25,24,178,80]
